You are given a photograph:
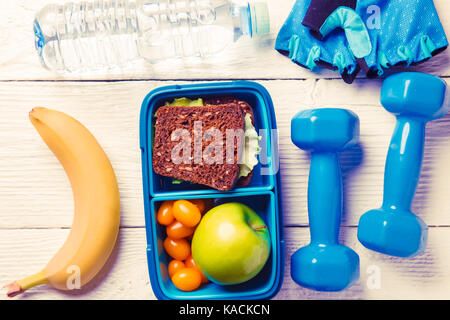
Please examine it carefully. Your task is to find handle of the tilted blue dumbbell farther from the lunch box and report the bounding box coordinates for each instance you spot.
[383,116,426,211]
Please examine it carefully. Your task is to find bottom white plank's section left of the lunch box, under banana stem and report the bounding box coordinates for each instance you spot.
[0,228,154,300]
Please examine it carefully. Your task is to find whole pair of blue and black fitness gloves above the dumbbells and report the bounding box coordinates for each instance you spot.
[275,0,448,83]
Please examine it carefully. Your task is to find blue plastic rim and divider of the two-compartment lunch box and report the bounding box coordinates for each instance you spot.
[140,81,285,299]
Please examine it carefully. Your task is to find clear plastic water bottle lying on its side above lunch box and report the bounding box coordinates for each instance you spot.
[34,0,270,73]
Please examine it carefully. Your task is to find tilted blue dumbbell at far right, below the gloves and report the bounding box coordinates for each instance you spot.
[358,72,448,257]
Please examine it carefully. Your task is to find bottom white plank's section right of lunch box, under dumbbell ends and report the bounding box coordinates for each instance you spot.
[276,228,450,300]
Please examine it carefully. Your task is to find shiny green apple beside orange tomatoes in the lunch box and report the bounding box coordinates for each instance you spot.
[192,202,270,284]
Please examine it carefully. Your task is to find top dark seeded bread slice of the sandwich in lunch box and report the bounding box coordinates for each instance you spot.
[153,103,244,191]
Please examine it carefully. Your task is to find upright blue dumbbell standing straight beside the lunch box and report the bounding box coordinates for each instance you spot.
[291,109,359,291]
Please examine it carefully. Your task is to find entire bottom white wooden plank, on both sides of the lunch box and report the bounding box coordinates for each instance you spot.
[0,228,450,300]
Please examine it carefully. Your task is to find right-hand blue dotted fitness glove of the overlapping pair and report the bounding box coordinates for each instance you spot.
[356,0,448,77]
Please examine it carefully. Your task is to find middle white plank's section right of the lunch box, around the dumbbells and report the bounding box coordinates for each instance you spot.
[282,79,450,226]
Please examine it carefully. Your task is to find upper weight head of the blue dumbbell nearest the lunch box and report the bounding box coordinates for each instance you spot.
[291,108,359,152]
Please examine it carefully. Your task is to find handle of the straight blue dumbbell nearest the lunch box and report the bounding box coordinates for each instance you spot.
[308,152,342,245]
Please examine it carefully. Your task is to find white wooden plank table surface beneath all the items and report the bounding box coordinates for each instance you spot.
[0,0,450,299]
